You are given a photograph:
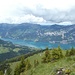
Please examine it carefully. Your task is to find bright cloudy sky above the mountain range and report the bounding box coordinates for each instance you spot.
[0,0,75,25]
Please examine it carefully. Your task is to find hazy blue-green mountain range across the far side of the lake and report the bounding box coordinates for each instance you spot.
[0,23,75,44]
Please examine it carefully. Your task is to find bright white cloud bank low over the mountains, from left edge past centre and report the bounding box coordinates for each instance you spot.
[0,14,46,24]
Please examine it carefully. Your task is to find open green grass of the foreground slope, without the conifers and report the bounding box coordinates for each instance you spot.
[10,47,75,75]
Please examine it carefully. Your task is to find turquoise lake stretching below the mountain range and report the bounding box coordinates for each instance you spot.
[1,38,75,50]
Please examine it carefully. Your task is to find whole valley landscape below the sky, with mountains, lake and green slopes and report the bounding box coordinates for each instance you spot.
[0,23,75,75]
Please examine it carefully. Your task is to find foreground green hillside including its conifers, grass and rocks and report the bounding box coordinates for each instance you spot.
[0,47,75,75]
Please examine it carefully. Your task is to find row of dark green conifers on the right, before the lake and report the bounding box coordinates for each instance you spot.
[42,46,75,63]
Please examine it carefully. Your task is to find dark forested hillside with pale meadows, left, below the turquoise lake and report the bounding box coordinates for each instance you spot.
[0,39,40,61]
